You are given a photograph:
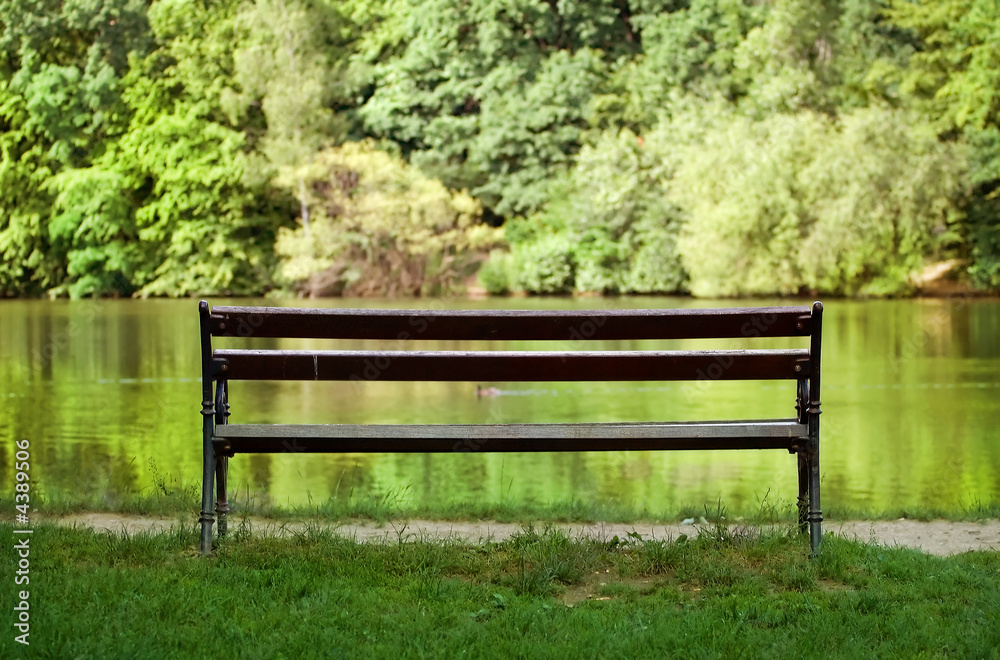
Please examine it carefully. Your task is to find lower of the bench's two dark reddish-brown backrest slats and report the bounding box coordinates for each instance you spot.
[215,349,810,382]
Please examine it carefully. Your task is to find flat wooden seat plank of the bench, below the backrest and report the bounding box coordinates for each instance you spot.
[215,419,809,453]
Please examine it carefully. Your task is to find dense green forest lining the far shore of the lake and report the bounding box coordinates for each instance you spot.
[0,0,1000,297]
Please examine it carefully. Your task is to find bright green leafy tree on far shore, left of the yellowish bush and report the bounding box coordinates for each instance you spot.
[121,0,291,296]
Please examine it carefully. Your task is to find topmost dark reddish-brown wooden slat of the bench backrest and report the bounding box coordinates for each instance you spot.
[211,307,812,341]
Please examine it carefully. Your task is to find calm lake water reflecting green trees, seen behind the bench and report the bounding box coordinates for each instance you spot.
[0,297,1000,512]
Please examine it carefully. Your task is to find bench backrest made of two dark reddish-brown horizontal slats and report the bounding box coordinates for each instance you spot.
[201,303,822,395]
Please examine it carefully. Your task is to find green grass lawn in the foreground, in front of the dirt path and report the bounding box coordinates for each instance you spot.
[0,524,1000,660]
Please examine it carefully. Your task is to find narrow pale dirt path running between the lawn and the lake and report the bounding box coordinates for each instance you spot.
[50,513,1000,556]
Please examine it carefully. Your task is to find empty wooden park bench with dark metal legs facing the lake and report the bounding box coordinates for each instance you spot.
[199,301,823,554]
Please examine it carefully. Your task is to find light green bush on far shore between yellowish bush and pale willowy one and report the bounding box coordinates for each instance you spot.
[507,129,686,293]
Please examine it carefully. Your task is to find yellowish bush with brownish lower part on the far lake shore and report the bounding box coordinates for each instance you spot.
[275,141,498,295]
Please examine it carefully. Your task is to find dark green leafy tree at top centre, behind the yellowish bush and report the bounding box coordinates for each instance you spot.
[359,0,639,215]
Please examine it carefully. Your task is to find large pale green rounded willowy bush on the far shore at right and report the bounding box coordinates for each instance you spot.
[672,104,963,296]
